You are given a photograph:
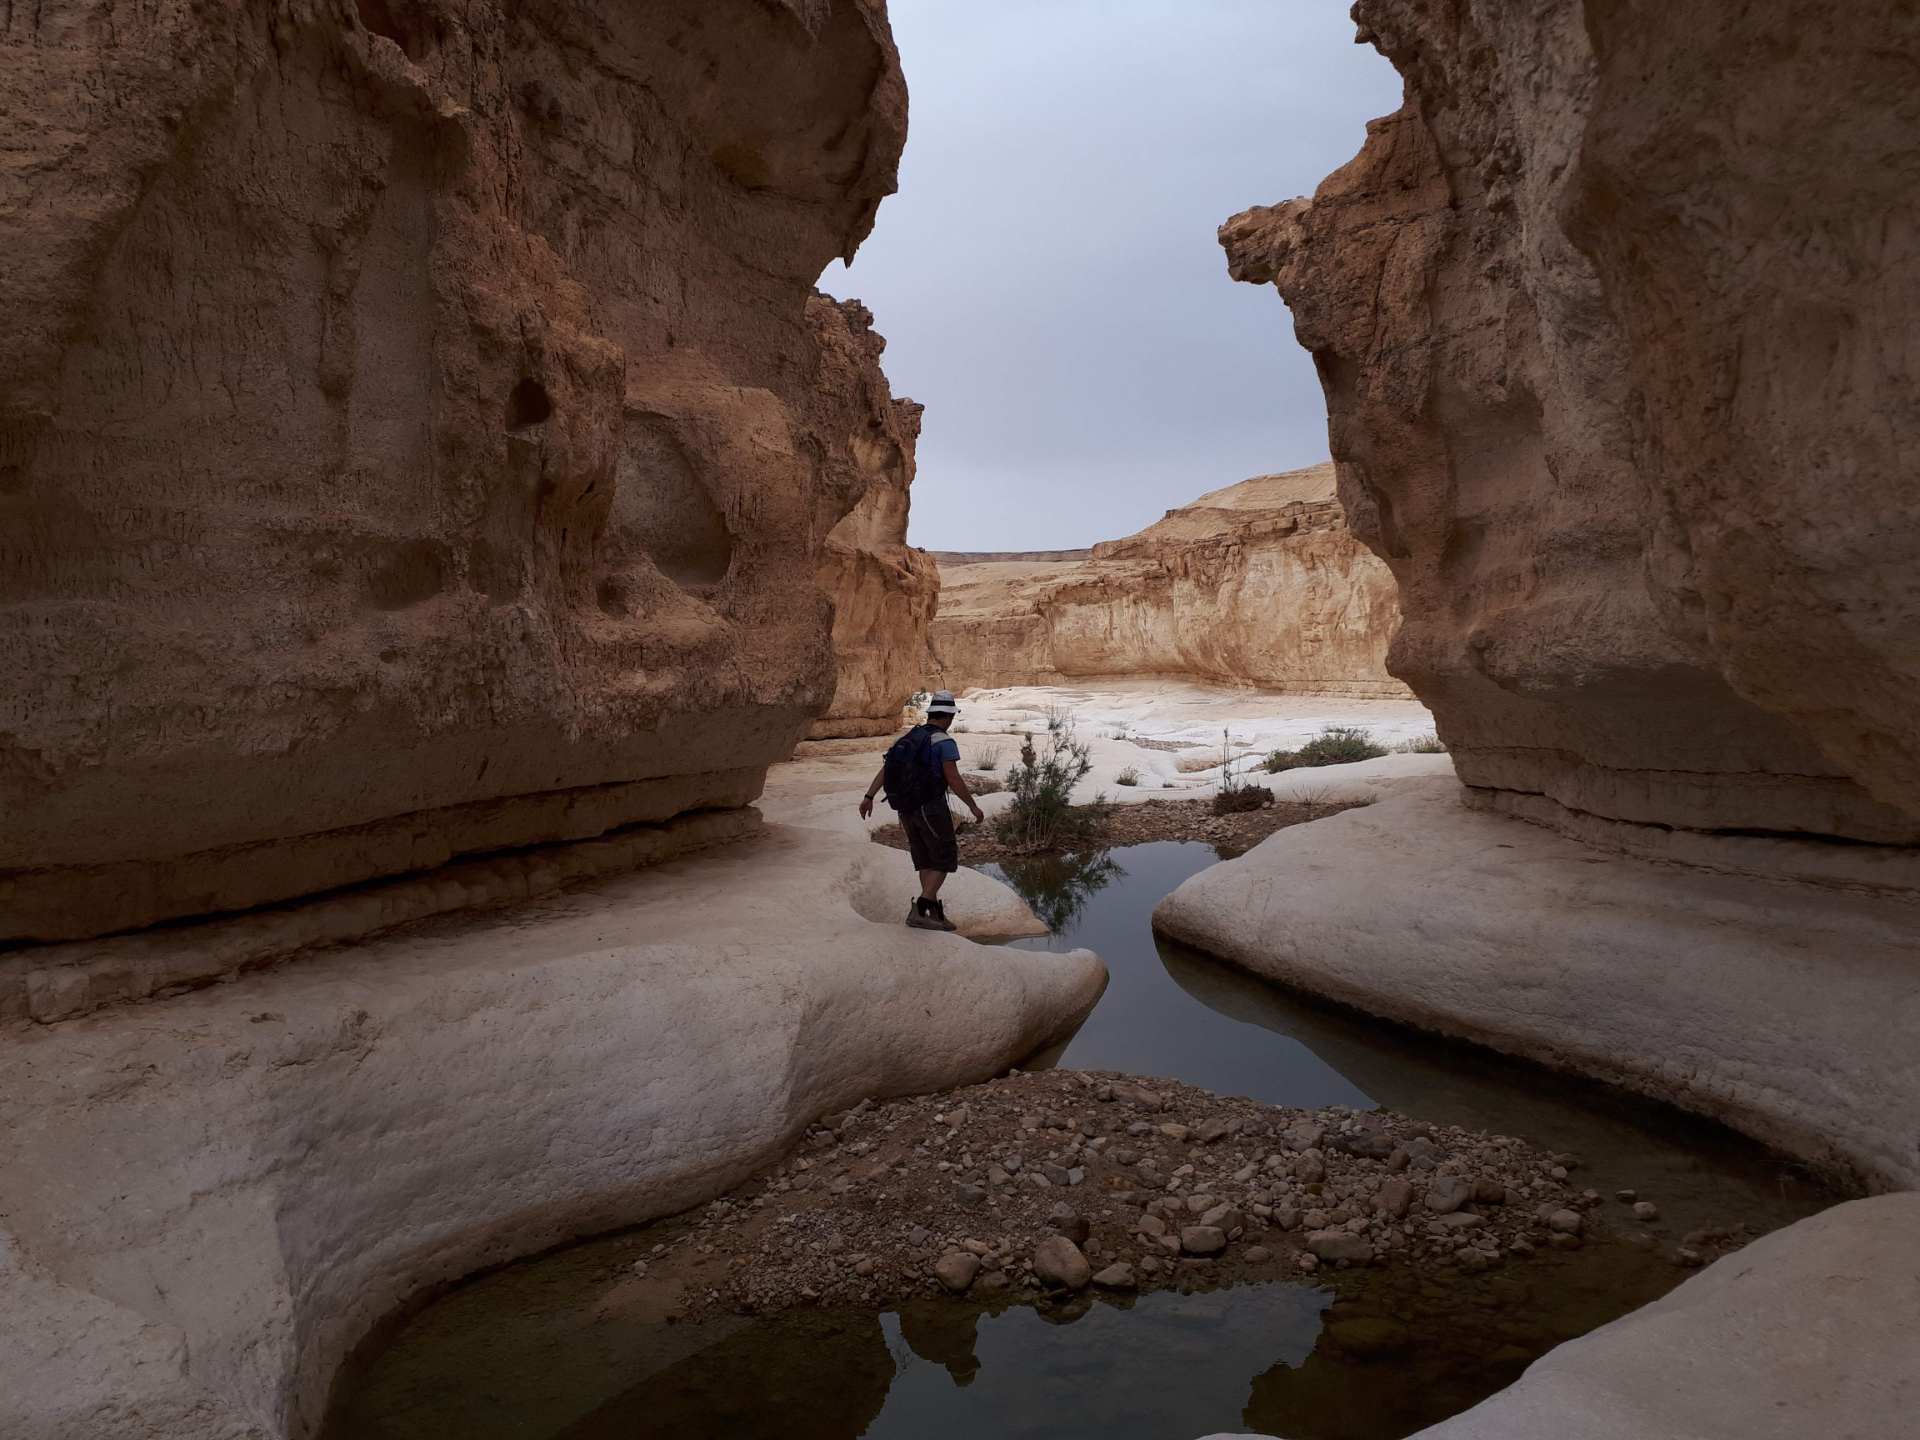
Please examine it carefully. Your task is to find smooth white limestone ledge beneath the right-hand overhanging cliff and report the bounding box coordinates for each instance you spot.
[1154,772,1920,1190]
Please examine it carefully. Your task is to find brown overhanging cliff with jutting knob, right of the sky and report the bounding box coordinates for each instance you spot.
[1221,0,1920,843]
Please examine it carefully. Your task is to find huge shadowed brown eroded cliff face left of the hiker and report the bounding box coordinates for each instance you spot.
[0,0,906,941]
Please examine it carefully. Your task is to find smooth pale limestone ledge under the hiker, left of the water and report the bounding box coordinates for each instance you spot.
[0,826,1106,1440]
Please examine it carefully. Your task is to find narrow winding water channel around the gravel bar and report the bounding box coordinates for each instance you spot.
[328,841,1836,1440]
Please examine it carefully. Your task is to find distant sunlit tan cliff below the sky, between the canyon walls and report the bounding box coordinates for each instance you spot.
[933,465,1405,697]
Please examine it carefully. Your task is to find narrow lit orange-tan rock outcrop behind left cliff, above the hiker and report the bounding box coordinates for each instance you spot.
[806,296,941,739]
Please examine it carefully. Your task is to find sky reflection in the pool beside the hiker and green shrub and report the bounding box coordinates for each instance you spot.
[981,841,1373,1110]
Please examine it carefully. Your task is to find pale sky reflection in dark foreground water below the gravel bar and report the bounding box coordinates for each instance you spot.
[866,1284,1332,1440]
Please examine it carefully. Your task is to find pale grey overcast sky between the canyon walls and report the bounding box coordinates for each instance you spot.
[820,0,1400,549]
